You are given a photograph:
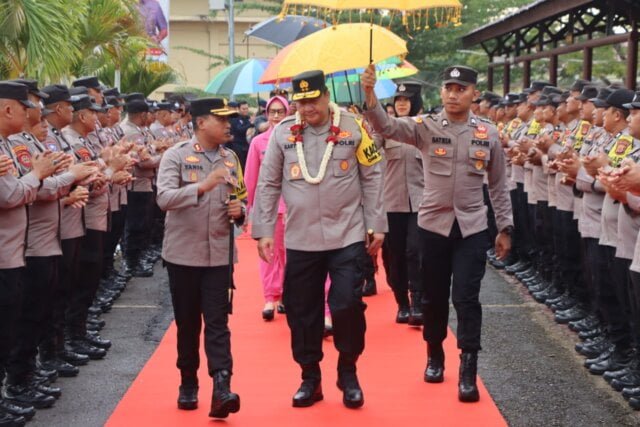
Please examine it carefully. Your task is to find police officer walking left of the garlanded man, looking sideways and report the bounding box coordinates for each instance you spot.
[158,98,246,418]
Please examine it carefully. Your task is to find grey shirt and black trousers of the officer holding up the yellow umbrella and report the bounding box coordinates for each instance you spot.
[365,103,513,351]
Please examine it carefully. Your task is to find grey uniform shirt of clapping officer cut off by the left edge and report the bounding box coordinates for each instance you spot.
[0,137,40,269]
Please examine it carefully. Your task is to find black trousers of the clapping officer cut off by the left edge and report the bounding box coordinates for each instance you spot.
[0,267,24,384]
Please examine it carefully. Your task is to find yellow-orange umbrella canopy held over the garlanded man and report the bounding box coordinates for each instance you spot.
[260,24,407,83]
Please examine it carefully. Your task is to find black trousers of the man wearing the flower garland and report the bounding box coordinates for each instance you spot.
[283,242,368,365]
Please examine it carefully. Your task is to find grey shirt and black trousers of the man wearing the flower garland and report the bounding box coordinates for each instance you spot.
[252,112,387,365]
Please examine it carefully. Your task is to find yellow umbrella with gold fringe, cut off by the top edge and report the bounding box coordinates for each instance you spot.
[282,0,462,29]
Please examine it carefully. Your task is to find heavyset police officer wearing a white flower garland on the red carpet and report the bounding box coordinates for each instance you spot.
[252,71,387,408]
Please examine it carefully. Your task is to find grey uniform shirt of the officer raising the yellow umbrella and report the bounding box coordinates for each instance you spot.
[366,103,513,237]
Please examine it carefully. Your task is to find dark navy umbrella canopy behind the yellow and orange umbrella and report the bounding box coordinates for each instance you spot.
[245,15,329,47]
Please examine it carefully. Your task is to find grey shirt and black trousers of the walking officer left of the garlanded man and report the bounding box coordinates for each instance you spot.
[157,137,246,378]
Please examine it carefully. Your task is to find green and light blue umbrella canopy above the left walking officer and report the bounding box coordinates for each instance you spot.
[204,58,274,95]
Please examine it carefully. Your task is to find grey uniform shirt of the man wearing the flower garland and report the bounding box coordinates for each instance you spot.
[252,112,388,251]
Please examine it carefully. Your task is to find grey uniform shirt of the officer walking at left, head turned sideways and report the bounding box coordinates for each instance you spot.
[157,137,244,267]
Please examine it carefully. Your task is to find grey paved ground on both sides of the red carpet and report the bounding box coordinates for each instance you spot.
[29,265,640,427]
